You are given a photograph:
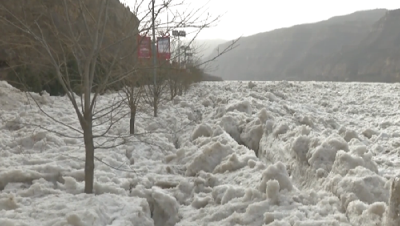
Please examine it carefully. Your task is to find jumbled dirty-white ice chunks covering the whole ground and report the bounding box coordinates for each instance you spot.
[0,82,400,226]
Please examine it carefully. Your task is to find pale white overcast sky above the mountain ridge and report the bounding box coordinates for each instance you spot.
[125,0,400,40]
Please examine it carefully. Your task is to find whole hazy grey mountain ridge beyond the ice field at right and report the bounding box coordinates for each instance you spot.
[206,9,400,82]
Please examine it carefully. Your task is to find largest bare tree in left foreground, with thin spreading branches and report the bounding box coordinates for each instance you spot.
[0,0,138,193]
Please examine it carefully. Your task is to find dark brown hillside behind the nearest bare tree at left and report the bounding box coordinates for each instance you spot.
[0,0,139,95]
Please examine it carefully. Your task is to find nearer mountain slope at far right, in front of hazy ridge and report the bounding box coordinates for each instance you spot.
[310,10,400,82]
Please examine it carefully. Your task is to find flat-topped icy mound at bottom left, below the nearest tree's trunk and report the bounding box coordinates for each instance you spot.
[0,194,154,226]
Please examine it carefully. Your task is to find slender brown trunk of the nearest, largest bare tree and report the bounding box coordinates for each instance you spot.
[83,114,94,194]
